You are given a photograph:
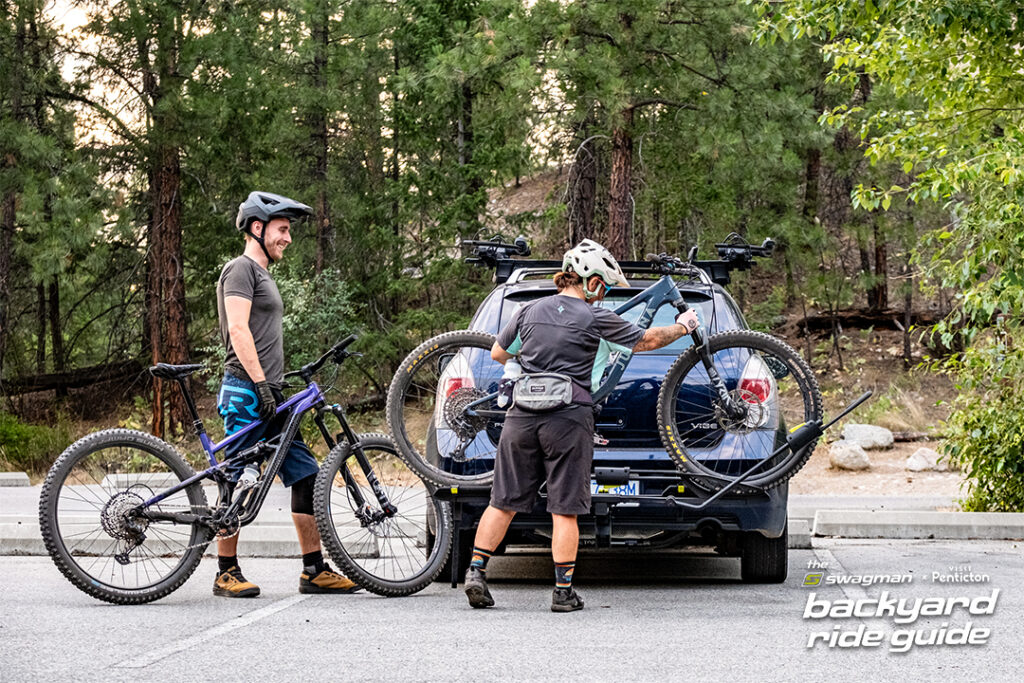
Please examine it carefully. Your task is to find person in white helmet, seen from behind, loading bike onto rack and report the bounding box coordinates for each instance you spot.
[465,240,698,612]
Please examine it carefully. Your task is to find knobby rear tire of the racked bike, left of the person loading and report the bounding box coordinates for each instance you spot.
[385,330,496,486]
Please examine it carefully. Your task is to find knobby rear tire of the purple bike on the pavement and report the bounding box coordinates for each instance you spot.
[39,429,211,604]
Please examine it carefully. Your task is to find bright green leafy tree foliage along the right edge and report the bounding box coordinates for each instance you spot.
[758,0,1024,510]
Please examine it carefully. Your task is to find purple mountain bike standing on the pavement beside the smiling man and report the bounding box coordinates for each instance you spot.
[39,336,452,604]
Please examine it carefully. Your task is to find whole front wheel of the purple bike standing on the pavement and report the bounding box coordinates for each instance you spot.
[313,434,452,597]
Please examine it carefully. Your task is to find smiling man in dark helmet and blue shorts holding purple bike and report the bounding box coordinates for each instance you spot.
[213,193,358,598]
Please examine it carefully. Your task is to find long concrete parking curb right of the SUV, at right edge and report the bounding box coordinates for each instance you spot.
[814,510,1024,541]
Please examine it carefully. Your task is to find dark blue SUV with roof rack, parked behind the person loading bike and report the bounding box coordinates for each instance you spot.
[442,248,788,582]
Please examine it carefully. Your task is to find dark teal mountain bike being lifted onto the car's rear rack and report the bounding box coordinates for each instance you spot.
[387,240,843,493]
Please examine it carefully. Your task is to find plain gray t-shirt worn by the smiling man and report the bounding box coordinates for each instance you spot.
[217,256,285,388]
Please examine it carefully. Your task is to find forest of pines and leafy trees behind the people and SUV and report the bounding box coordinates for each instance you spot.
[0,0,1024,510]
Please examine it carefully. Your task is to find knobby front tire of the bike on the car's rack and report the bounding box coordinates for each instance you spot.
[657,330,822,493]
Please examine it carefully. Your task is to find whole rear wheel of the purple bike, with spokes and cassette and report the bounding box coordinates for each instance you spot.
[39,429,210,604]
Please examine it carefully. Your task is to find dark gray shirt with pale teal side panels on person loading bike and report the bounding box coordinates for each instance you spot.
[498,295,644,403]
